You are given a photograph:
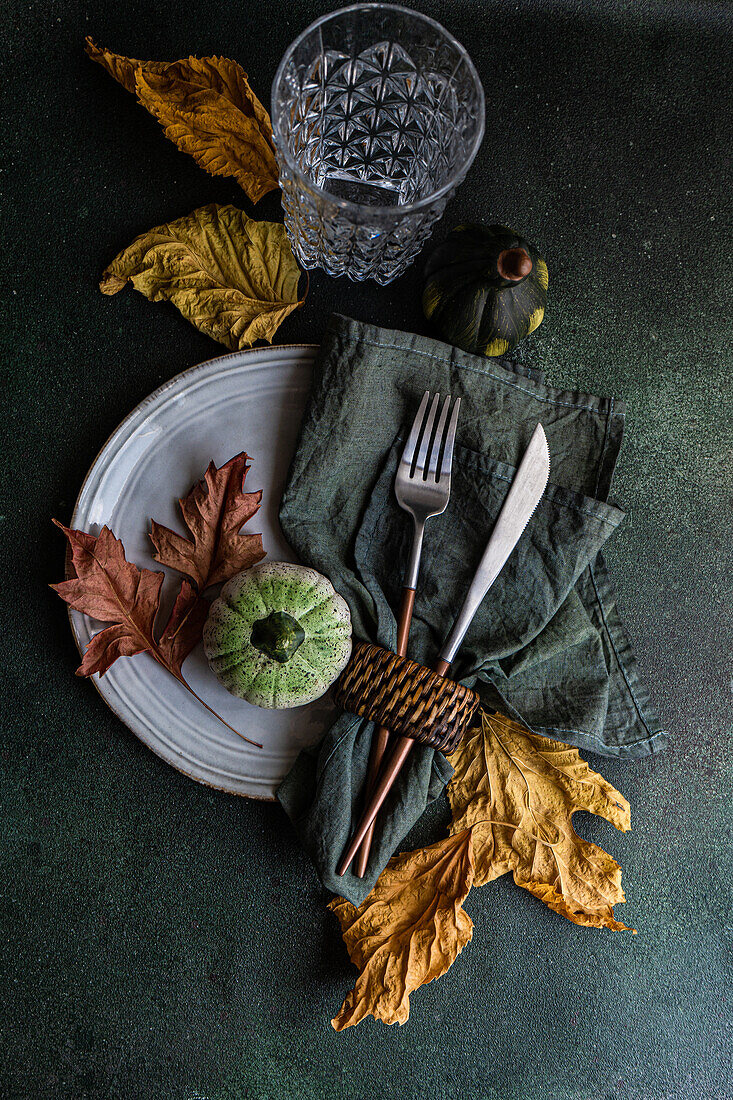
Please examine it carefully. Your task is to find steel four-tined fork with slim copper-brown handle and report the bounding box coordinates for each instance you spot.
[355,391,461,878]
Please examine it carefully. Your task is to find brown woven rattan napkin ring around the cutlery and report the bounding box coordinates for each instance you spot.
[333,641,480,754]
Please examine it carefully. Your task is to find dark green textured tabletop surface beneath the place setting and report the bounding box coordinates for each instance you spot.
[0,0,733,1100]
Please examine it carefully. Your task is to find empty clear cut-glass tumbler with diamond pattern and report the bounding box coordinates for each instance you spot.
[272,3,484,284]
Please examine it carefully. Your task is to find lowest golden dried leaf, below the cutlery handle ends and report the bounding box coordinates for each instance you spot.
[329,829,473,1031]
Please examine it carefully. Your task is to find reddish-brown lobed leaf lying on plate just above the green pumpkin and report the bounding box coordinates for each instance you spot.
[150,451,264,592]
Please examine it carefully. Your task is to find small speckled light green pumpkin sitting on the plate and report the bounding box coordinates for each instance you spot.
[204,561,351,708]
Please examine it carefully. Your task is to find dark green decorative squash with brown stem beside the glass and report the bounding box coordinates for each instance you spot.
[423,224,547,355]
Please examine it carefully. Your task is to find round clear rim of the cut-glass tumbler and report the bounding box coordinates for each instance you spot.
[270,3,486,218]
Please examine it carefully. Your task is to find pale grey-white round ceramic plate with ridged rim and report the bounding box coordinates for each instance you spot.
[70,344,332,799]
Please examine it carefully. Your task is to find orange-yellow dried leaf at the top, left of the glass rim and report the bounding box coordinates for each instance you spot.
[87,39,280,202]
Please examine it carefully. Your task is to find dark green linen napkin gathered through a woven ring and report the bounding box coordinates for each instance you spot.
[277,317,665,904]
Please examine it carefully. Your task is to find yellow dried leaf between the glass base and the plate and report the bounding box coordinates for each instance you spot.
[99,205,303,351]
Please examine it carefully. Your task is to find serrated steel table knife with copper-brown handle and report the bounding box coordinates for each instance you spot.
[336,424,550,875]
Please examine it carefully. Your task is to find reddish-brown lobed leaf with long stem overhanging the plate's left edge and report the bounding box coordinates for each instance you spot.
[51,519,262,748]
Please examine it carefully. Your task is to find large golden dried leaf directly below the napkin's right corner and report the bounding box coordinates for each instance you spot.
[448,714,631,930]
